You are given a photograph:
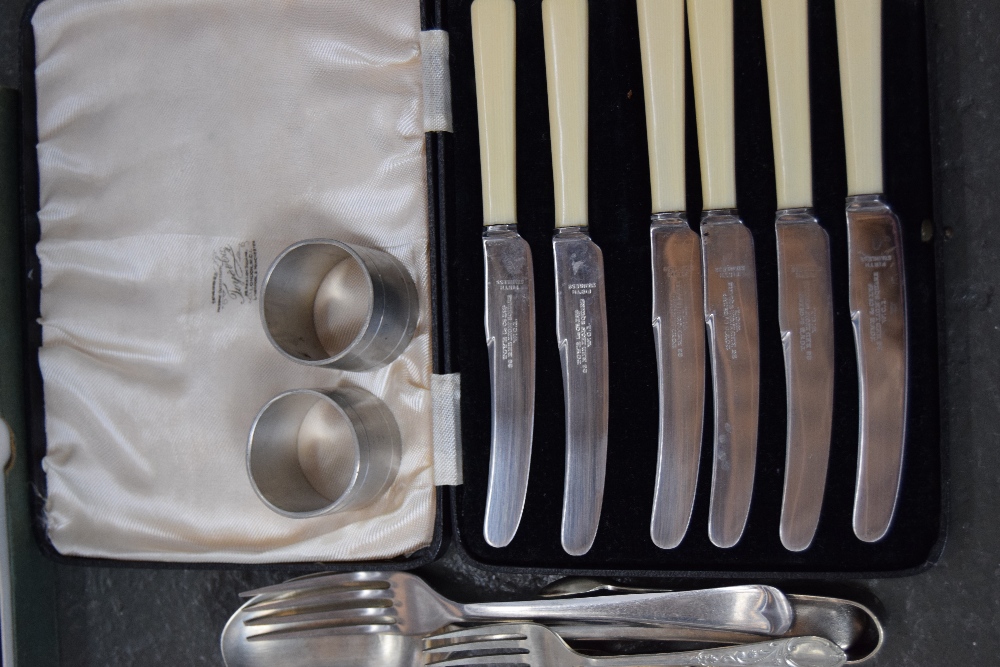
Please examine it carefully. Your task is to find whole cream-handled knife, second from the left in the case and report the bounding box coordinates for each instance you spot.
[542,0,608,556]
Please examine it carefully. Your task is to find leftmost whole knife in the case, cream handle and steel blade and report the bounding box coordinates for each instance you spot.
[472,0,535,547]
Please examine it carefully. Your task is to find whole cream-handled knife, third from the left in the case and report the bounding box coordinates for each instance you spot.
[637,0,705,549]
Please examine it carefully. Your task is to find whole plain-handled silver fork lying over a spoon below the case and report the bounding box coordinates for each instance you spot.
[241,572,794,641]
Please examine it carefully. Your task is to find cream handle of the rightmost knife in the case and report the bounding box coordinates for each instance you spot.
[836,0,882,196]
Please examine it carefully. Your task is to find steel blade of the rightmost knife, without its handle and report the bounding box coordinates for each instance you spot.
[847,195,907,542]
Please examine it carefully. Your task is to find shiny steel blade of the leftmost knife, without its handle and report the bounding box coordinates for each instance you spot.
[483,225,535,547]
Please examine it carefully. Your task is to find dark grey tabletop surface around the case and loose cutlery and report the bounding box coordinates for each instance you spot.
[0,0,1000,667]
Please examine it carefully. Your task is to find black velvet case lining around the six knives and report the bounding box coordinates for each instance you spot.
[438,0,944,577]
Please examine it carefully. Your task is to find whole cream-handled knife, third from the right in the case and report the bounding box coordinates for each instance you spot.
[687,0,760,547]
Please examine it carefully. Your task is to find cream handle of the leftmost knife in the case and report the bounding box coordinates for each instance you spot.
[472,0,517,225]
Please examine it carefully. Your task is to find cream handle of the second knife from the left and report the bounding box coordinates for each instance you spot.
[542,0,589,227]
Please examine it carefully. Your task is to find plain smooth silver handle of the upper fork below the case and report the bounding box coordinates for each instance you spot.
[462,586,794,635]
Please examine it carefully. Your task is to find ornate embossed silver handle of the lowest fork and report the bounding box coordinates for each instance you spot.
[587,637,847,667]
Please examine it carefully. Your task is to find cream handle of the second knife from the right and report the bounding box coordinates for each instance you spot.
[761,0,813,210]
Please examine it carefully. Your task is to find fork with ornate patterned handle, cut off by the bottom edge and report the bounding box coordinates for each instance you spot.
[424,623,847,667]
